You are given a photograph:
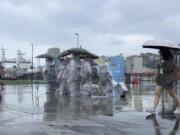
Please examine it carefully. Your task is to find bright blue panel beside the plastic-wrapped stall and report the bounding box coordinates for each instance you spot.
[109,56,124,82]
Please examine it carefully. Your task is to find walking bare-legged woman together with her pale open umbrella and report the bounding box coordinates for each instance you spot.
[143,40,180,114]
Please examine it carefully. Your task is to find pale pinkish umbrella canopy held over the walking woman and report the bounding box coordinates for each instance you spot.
[143,40,180,50]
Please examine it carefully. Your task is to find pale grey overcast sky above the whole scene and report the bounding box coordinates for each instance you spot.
[0,0,180,63]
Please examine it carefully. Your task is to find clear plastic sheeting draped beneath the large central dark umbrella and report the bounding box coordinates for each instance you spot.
[58,55,126,96]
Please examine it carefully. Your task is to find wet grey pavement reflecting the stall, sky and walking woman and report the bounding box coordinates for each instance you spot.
[0,83,180,135]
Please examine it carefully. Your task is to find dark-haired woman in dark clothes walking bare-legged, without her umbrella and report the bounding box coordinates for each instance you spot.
[146,48,180,114]
